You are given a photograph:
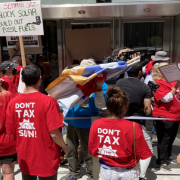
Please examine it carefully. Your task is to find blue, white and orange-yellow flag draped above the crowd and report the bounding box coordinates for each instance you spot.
[46,61,130,109]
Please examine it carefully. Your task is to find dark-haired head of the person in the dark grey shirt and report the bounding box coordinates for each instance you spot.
[127,62,142,79]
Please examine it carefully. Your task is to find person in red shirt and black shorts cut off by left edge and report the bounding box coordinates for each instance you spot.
[0,79,17,180]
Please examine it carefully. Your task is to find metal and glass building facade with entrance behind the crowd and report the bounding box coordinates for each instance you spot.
[0,0,180,82]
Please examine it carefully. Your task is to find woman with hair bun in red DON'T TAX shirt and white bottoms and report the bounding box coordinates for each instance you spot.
[89,86,152,180]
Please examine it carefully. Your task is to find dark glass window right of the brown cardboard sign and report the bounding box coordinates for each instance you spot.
[124,22,164,50]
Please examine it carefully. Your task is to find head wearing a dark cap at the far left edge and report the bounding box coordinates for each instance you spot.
[0,61,19,78]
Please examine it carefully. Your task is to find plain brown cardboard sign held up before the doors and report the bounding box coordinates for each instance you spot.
[65,28,111,60]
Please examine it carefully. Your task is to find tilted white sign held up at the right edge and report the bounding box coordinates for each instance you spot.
[159,64,180,82]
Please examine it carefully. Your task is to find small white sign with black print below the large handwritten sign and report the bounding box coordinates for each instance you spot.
[6,36,39,49]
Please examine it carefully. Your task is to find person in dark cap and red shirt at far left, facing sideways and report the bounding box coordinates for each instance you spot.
[0,61,18,98]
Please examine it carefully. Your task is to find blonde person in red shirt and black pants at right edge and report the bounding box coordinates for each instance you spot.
[152,63,180,171]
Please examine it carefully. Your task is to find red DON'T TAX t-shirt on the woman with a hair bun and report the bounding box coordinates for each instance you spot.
[89,118,152,168]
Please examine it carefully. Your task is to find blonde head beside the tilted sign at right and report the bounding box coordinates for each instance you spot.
[152,62,168,81]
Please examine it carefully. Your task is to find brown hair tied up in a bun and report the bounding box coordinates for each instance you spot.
[106,86,128,118]
